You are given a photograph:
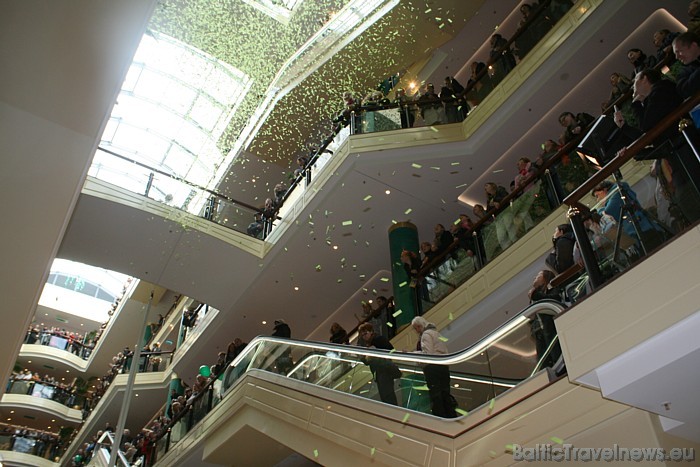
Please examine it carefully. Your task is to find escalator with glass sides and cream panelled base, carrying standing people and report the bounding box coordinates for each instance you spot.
[156,302,583,465]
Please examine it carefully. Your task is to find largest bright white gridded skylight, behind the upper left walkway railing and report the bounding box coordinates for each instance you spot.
[89,31,252,212]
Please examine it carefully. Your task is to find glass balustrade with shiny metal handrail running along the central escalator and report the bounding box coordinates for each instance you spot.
[150,301,564,455]
